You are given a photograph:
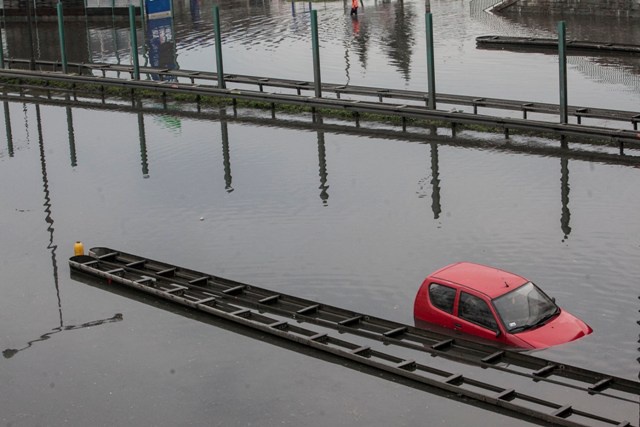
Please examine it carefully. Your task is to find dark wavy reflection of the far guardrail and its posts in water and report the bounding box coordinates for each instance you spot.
[4,95,640,242]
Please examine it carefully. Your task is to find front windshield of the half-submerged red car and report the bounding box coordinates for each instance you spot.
[493,282,559,333]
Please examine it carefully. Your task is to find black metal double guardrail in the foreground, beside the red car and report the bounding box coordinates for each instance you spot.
[69,247,640,426]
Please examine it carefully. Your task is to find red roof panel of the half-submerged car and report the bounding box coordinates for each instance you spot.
[431,262,528,299]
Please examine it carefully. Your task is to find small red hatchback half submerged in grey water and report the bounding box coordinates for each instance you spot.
[413,262,593,349]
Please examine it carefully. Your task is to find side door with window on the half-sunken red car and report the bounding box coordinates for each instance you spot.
[453,290,502,341]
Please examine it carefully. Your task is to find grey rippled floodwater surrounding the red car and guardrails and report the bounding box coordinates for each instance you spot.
[0,1,640,426]
